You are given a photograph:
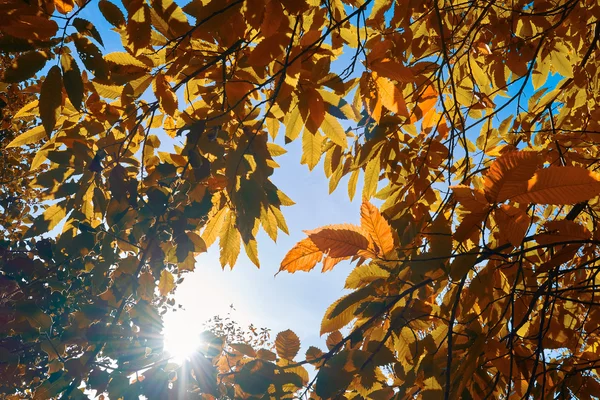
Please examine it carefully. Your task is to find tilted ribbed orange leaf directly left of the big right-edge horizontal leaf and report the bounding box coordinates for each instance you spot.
[483,151,540,203]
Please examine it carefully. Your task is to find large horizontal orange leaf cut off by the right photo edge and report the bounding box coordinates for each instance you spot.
[510,166,600,205]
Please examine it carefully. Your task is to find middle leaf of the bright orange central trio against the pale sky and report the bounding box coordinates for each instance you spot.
[306,224,369,258]
